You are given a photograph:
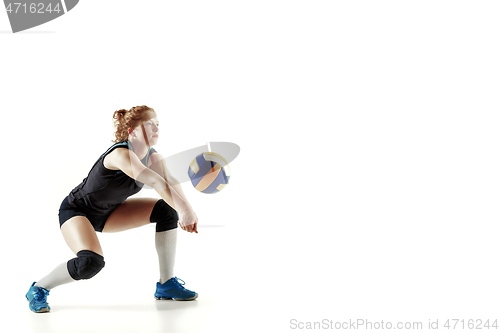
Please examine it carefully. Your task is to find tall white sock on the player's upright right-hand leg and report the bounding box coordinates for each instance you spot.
[155,228,177,284]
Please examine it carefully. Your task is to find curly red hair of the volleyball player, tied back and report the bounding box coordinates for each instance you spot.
[113,105,156,143]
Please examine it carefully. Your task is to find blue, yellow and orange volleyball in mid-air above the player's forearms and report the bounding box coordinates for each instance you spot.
[188,152,230,194]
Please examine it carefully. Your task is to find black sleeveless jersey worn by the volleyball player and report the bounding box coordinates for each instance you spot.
[68,141,156,215]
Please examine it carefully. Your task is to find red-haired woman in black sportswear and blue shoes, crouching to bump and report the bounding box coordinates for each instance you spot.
[26,105,198,312]
